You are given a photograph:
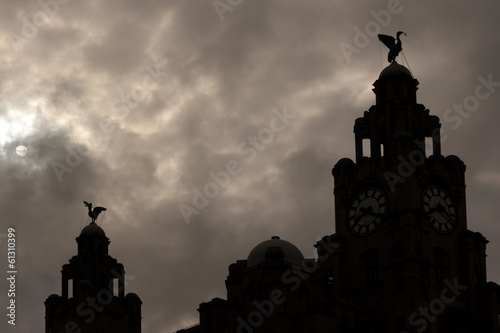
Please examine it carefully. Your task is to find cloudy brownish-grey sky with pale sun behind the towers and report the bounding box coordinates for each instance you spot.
[0,0,500,333]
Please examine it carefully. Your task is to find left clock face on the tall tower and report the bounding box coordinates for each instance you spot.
[347,188,388,236]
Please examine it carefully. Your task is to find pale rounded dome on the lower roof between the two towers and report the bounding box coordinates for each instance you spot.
[247,236,304,267]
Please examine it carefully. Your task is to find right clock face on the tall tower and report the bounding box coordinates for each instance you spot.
[422,186,457,234]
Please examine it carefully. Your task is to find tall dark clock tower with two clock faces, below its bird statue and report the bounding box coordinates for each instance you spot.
[317,62,500,333]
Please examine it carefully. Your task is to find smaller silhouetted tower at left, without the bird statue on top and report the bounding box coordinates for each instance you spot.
[45,222,142,333]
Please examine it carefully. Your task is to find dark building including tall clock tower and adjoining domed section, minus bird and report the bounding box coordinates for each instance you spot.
[178,62,500,333]
